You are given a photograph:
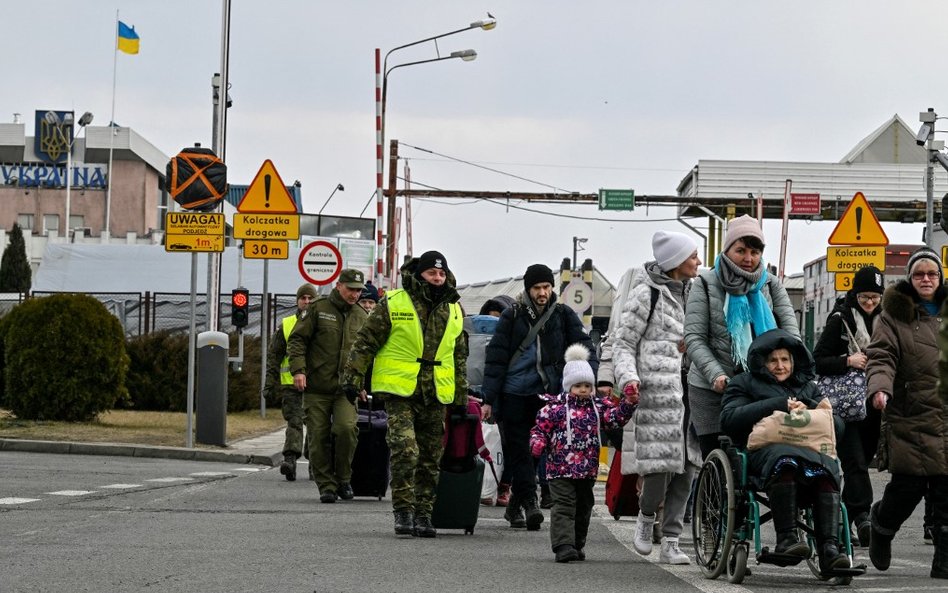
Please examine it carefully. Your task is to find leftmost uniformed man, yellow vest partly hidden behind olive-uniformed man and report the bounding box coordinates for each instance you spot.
[264,283,316,482]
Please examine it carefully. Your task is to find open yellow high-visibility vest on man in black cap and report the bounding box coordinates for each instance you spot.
[372,289,464,404]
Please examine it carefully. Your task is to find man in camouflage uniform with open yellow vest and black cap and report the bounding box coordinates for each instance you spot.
[344,251,467,537]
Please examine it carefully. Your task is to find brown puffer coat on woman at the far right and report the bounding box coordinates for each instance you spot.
[866,280,948,476]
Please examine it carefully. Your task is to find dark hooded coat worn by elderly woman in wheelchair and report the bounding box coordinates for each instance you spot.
[721,329,844,488]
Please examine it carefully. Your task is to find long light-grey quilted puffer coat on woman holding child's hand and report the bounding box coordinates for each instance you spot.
[612,268,701,474]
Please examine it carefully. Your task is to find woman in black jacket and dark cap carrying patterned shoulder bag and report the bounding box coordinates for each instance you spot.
[813,266,885,546]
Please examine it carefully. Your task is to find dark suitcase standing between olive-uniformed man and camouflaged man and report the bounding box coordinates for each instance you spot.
[350,399,391,500]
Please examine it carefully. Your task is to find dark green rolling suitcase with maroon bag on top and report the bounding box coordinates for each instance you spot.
[431,400,489,535]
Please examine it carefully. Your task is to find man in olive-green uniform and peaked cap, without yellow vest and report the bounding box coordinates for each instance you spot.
[287,270,367,503]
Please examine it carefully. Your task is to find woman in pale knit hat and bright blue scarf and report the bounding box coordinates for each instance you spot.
[685,215,800,457]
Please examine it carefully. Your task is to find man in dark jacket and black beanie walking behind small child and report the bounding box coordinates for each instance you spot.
[481,264,599,531]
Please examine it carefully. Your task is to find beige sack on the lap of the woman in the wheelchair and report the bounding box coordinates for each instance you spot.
[747,398,836,459]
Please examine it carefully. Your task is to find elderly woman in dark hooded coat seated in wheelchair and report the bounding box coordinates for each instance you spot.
[721,329,849,574]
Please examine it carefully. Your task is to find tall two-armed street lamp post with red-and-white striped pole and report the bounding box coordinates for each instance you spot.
[375,16,497,286]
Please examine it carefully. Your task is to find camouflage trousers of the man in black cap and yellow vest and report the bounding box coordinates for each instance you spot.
[385,395,444,517]
